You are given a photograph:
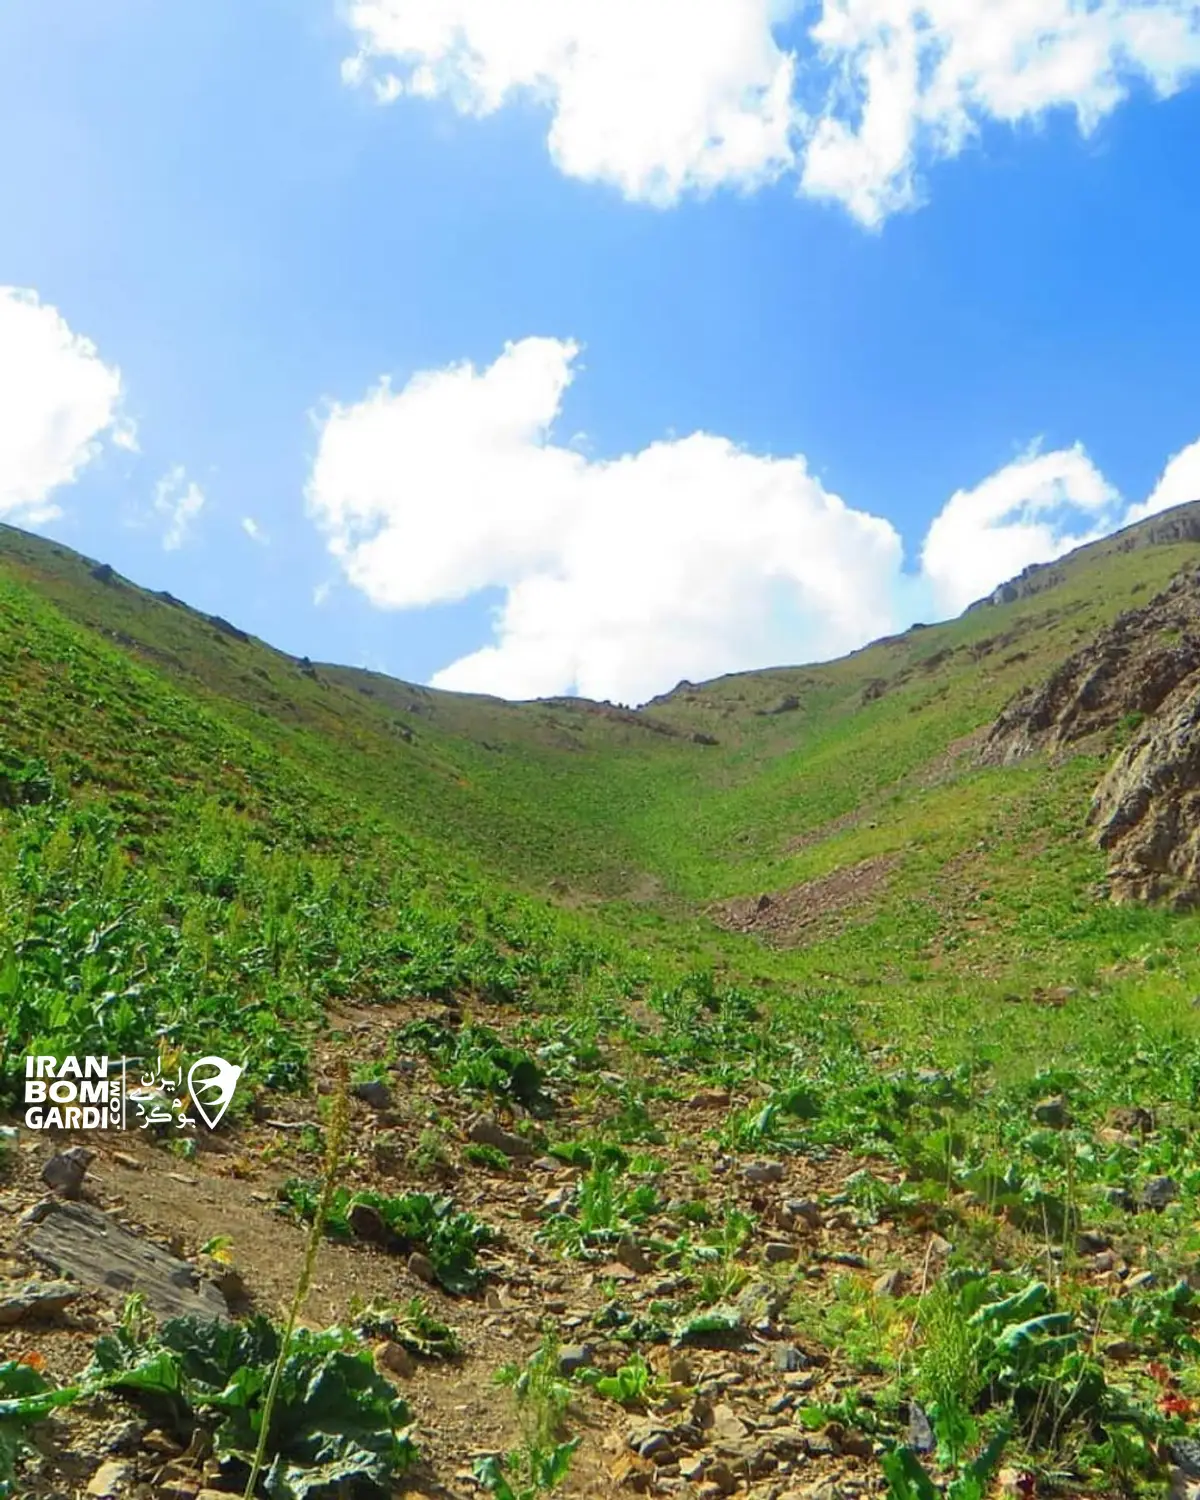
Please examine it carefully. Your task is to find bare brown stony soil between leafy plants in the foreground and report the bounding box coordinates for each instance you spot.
[0,1007,951,1500]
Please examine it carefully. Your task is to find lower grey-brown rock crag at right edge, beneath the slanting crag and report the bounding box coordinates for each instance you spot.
[1089,675,1200,908]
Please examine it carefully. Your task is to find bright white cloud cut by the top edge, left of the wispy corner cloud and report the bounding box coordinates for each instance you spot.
[344,0,795,204]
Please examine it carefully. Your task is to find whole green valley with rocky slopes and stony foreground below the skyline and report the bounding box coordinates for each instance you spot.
[0,503,1200,1500]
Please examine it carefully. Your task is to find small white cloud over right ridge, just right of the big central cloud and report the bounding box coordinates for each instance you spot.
[921,443,1119,615]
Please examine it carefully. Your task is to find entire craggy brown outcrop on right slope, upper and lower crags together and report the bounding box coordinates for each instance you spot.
[980,570,1200,906]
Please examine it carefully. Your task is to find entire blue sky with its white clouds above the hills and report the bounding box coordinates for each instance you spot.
[0,0,1200,701]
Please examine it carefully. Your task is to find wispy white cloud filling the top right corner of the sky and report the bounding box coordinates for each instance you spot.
[803,0,1200,225]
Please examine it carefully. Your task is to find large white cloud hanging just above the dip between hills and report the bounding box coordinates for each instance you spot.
[308,339,902,702]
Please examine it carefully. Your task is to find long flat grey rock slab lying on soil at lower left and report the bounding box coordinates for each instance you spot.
[24,1202,230,1320]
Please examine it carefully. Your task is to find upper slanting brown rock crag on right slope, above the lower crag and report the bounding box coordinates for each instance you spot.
[980,570,1200,765]
